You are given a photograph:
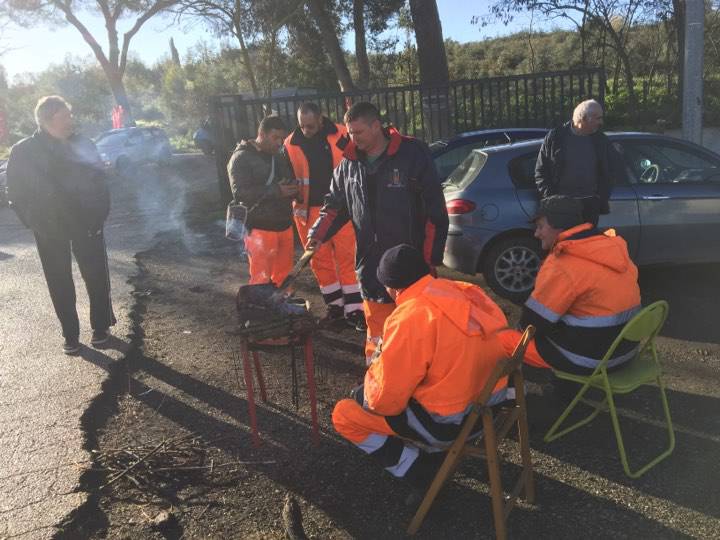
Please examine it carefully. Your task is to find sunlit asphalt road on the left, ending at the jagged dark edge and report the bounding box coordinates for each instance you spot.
[0,156,207,538]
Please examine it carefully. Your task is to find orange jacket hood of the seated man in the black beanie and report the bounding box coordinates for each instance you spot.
[398,275,507,336]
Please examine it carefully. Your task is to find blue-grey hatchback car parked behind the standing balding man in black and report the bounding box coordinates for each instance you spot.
[444,133,720,302]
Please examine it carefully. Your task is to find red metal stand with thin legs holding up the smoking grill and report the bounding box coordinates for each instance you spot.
[240,332,320,447]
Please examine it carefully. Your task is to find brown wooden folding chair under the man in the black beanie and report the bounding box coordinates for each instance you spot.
[407,326,535,539]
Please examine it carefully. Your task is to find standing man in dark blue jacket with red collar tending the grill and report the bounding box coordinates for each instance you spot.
[308,102,448,362]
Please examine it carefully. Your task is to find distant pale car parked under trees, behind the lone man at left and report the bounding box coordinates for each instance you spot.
[95,127,172,172]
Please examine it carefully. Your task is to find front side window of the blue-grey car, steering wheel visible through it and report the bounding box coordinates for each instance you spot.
[623,141,720,184]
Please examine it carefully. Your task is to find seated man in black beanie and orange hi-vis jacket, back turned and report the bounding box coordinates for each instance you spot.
[332,244,514,487]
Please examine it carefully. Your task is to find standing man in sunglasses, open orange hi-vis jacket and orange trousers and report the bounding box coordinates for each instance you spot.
[285,103,367,332]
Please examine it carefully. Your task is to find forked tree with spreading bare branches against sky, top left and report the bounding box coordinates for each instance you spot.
[0,0,176,120]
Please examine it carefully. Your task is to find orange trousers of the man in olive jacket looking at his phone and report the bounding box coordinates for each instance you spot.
[245,227,295,285]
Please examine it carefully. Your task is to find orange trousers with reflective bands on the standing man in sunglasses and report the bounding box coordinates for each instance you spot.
[295,206,362,313]
